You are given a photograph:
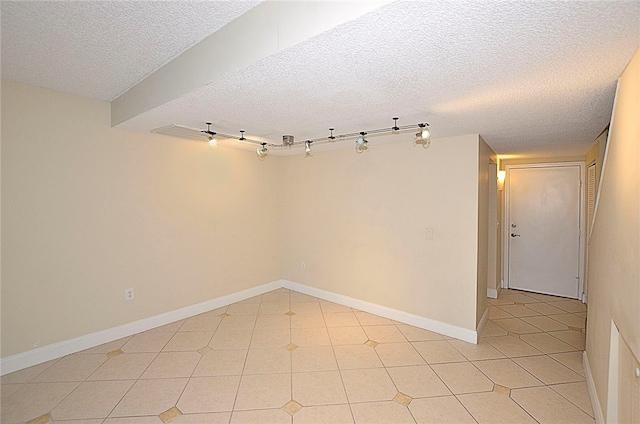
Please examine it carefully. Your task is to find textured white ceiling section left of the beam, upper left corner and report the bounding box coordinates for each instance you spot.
[1,0,260,101]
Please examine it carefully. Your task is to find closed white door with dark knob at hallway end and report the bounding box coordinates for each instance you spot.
[507,165,581,299]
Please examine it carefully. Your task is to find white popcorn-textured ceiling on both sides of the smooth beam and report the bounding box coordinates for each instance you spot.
[2,1,640,156]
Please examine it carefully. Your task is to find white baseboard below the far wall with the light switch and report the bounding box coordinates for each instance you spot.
[282,280,478,344]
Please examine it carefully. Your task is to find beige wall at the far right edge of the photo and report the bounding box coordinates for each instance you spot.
[587,51,640,416]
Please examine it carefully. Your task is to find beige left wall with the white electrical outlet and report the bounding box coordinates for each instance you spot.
[2,81,282,357]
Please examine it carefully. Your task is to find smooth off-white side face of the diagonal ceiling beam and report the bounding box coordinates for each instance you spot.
[111,0,389,126]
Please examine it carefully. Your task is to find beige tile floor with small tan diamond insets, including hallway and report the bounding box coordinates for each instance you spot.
[0,289,594,424]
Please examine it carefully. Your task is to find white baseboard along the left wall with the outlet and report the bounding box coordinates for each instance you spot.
[0,280,283,375]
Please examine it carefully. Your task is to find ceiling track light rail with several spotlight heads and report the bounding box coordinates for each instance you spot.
[168,117,431,160]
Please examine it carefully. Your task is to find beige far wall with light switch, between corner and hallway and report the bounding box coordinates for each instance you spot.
[282,135,486,329]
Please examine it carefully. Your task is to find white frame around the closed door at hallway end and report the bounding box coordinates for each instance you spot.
[502,161,587,303]
